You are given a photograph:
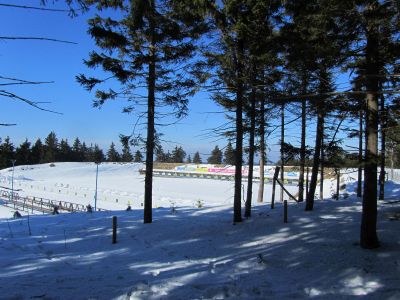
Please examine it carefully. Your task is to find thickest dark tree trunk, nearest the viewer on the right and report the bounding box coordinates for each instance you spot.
[360,7,379,249]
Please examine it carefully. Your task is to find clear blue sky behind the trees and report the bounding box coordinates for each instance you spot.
[0,0,358,161]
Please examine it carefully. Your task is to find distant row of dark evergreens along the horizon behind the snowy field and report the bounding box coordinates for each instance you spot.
[0,132,235,169]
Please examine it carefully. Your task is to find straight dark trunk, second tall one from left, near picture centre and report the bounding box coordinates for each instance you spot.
[233,39,243,223]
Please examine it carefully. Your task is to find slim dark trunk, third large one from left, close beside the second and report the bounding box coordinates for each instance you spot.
[244,71,256,218]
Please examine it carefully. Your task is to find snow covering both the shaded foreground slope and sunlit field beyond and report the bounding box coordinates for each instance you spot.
[0,163,400,300]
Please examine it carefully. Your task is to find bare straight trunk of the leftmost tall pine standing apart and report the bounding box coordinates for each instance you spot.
[143,0,156,223]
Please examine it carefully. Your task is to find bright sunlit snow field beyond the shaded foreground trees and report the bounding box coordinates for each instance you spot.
[0,163,304,214]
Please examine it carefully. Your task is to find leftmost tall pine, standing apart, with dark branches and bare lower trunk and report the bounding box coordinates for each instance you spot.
[77,0,206,223]
